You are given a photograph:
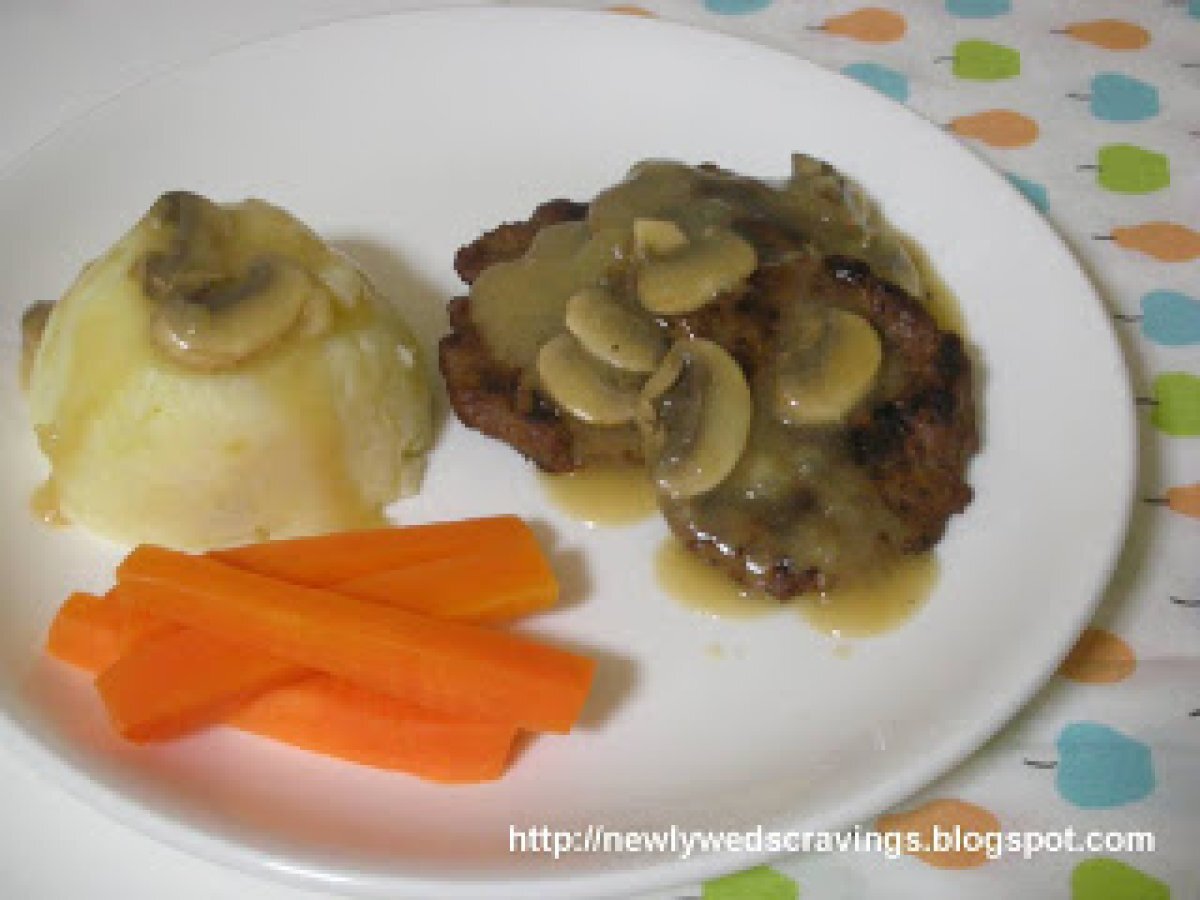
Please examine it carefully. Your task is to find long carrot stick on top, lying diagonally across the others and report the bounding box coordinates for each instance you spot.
[118,546,595,732]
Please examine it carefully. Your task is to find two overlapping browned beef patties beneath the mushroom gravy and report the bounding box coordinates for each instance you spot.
[439,167,978,598]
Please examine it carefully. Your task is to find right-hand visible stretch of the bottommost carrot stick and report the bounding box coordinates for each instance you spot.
[226,673,516,784]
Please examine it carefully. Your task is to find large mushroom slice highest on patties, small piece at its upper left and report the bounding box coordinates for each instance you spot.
[637,229,758,316]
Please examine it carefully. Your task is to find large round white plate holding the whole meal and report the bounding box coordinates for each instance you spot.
[0,10,1134,896]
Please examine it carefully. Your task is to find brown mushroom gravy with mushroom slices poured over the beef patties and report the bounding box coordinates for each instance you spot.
[470,156,955,595]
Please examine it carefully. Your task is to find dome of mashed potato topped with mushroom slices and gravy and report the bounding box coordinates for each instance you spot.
[29,191,431,548]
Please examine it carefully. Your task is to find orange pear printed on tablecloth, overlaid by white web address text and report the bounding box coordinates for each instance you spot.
[875,799,1003,869]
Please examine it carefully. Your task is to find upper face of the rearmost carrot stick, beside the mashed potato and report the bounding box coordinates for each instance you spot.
[210,516,534,588]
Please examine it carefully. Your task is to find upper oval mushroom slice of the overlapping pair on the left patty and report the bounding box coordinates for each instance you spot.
[565,287,666,373]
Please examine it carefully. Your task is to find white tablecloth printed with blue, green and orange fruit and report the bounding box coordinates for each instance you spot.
[549,0,1200,900]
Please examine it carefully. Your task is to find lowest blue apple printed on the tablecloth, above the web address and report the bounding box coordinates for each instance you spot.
[1055,722,1154,809]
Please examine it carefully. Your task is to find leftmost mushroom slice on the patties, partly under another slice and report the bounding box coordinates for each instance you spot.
[538,334,644,425]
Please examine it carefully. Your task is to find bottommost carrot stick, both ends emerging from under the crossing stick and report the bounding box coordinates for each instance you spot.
[47,593,516,782]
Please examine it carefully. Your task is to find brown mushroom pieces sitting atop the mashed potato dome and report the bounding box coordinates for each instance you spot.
[139,191,319,370]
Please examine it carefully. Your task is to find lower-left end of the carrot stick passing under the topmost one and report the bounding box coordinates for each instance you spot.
[96,628,308,743]
